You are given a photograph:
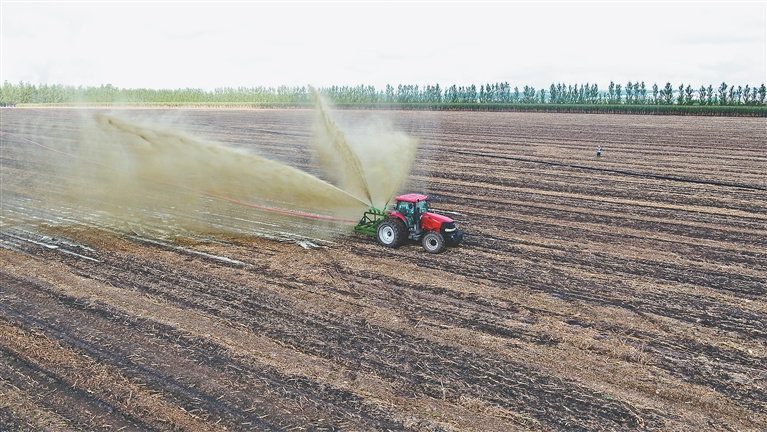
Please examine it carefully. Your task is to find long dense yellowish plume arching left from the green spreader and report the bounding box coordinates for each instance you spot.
[84,114,365,216]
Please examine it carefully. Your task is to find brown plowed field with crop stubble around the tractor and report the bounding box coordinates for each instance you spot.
[0,109,767,431]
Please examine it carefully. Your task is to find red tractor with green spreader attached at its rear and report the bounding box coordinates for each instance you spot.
[354,194,463,253]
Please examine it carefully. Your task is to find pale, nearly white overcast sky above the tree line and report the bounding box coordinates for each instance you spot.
[0,0,767,90]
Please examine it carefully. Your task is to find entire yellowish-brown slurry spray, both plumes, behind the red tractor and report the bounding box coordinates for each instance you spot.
[3,93,417,240]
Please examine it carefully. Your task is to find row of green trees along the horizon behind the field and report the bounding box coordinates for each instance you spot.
[0,81,767,106]
